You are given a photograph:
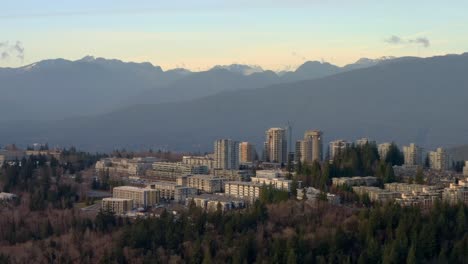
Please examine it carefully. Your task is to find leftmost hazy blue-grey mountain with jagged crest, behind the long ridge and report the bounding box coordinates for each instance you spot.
[0,56,187,120]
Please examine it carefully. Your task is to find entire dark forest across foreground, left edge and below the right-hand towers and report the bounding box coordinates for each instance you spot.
[0,145,468,263]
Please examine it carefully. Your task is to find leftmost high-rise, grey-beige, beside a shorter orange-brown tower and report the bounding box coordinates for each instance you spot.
[214,139,239,170]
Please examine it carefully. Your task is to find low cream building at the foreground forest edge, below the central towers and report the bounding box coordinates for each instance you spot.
[187,194,245,212]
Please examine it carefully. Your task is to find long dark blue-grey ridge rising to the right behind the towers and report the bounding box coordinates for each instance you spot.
[0,54,468,150]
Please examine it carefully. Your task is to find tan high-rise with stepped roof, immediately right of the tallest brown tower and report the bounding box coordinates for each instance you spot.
[296,130,323,164]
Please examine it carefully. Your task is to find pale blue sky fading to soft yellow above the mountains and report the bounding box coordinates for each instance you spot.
[0,0,468,71]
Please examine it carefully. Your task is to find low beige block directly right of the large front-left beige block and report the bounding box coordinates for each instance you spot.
[147,181,198,202]
